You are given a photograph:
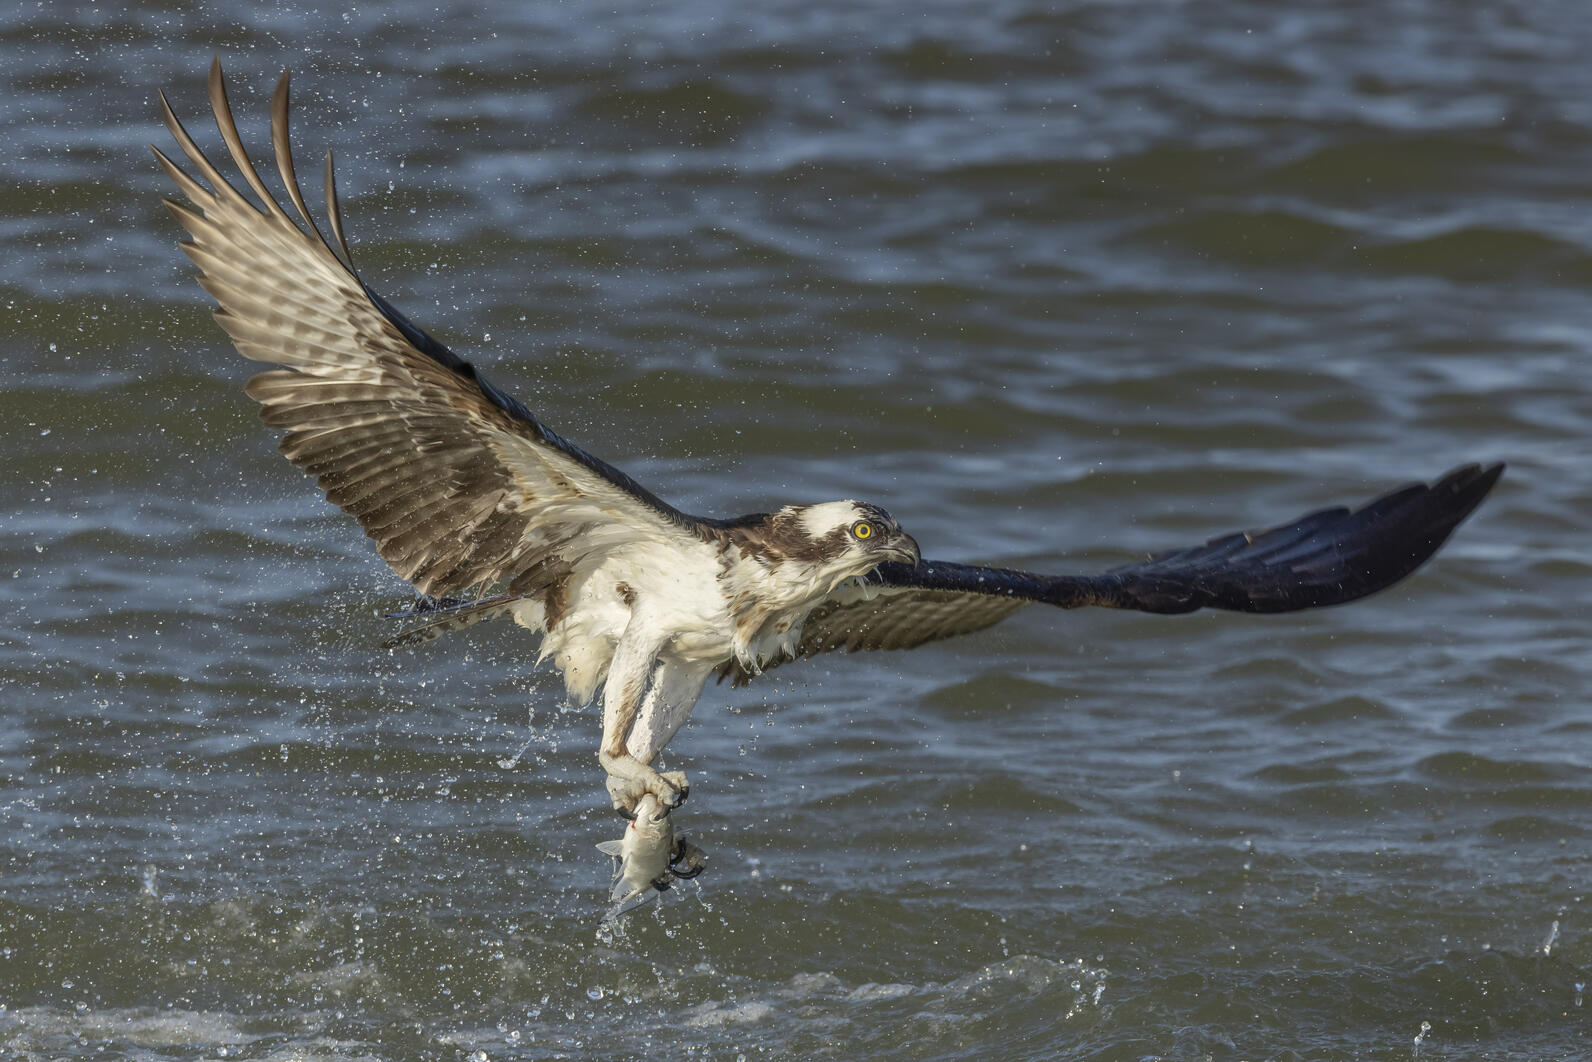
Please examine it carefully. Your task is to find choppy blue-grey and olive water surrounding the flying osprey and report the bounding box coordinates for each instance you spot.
[0,0,1592,1060]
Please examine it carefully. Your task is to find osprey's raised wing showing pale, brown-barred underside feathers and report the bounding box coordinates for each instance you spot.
[154,59,716,594]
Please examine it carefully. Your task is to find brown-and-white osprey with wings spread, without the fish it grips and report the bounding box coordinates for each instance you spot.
[154,61,1503,817]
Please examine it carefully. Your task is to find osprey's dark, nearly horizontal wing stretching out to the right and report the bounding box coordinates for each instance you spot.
[721,465,1503,681]
